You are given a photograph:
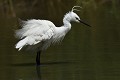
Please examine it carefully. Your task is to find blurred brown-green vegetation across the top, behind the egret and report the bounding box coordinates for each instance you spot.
[0,0,120,24]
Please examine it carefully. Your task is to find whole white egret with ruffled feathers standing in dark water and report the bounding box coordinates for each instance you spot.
[15,6,90,65]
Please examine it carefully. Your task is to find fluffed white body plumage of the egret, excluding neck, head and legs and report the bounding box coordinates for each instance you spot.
[16,19,67,50]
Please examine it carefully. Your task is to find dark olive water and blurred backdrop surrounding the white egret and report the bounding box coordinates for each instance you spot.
[0,0,120,80]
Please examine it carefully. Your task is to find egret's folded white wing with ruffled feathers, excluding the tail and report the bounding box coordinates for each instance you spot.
[16,19,55,49]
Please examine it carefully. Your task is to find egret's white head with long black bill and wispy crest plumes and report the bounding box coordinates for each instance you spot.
[64,6,91,27]
